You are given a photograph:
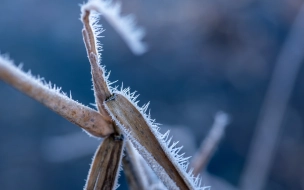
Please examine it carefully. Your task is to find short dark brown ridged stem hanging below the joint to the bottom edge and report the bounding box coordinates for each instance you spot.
[85,135,124,190]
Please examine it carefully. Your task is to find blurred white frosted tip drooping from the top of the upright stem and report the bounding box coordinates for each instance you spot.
[82,0,147,55]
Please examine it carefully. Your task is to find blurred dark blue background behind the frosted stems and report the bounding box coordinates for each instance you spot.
[0,0,304,190]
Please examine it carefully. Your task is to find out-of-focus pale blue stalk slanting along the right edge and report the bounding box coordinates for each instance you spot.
[241,2,304,190]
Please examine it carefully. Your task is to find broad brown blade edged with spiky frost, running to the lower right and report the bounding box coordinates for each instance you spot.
[105,94,209,189]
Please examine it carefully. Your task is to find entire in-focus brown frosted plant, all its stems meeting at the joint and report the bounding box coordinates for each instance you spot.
[0,0,213,190]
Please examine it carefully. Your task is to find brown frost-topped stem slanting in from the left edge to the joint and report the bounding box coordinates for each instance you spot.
[0,56,114,137]
